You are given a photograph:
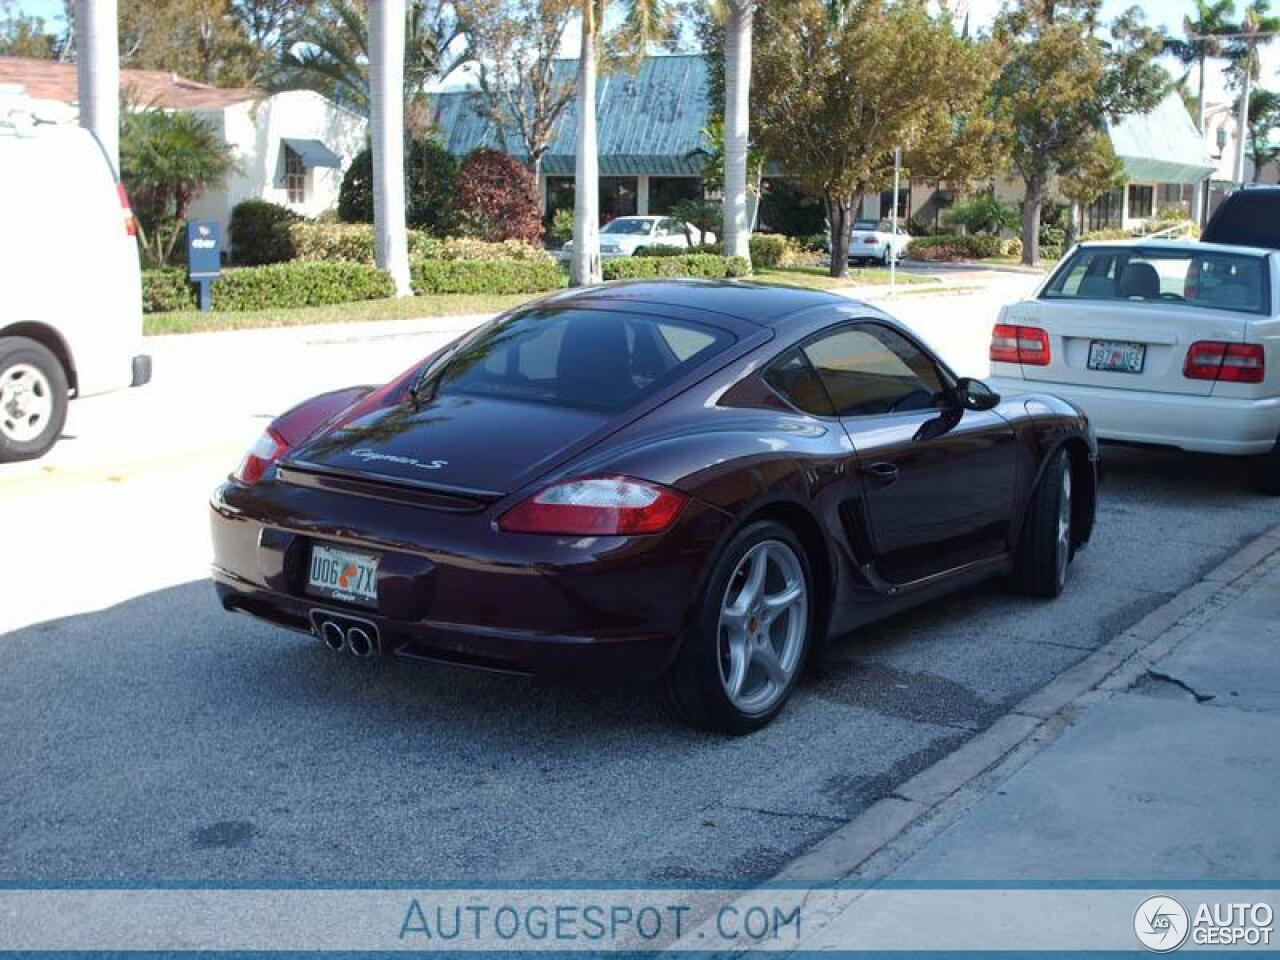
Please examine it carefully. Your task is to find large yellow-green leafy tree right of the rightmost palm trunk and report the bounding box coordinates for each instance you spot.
[753,0,998,276]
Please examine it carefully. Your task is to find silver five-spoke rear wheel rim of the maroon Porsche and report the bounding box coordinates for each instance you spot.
[717,540,809,714]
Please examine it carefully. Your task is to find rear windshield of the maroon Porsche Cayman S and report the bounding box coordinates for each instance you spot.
[435,310,733,412]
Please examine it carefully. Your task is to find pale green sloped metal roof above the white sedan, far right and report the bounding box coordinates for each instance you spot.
[1107,93,1217,183]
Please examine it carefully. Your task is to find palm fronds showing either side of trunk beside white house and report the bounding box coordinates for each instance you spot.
[268,0,471,111]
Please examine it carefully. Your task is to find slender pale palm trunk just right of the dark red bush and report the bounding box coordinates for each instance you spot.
[570,0,600,287]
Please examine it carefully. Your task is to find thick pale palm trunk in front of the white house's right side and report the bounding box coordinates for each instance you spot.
[369,0,413,297]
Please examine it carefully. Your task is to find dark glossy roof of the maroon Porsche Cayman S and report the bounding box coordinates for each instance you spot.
[524,279,858,326]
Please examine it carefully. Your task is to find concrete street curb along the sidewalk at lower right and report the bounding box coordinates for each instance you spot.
[769,526,1280,886]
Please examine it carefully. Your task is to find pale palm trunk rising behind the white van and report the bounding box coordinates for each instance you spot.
[76,0,120,173]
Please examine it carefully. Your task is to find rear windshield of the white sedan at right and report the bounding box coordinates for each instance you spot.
[1041,246,1271,314]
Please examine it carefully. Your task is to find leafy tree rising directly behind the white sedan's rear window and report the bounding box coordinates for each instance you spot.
[995,0,1169,264]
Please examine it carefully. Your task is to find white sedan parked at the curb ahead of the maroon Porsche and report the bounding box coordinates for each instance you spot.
[988,241,1280,494]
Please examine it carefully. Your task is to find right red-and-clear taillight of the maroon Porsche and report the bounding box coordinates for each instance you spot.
[498,476,689,536]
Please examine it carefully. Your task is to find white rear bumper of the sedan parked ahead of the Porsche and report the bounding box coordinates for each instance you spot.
[987,376,1280,457]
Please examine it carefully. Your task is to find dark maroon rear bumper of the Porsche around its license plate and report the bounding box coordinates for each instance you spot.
[211,483,727,682]
